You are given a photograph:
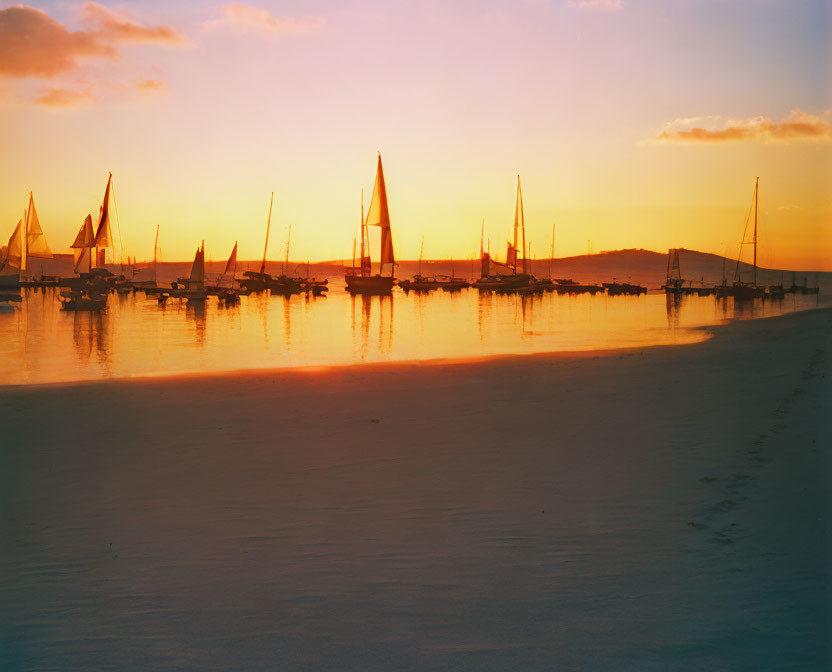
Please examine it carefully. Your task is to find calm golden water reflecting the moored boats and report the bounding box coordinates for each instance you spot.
[0,282,823,384]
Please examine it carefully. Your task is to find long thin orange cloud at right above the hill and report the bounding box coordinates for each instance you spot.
[653,110,832,144]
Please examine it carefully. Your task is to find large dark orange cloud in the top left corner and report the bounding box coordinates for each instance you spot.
[0,2,182,79]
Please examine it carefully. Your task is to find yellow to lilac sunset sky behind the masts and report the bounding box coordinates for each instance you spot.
[0,0,832,271]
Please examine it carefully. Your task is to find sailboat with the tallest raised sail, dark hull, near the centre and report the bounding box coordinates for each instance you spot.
[344,154,396,294]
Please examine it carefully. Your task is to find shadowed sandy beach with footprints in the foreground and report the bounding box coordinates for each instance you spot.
[0,309,832,671]
